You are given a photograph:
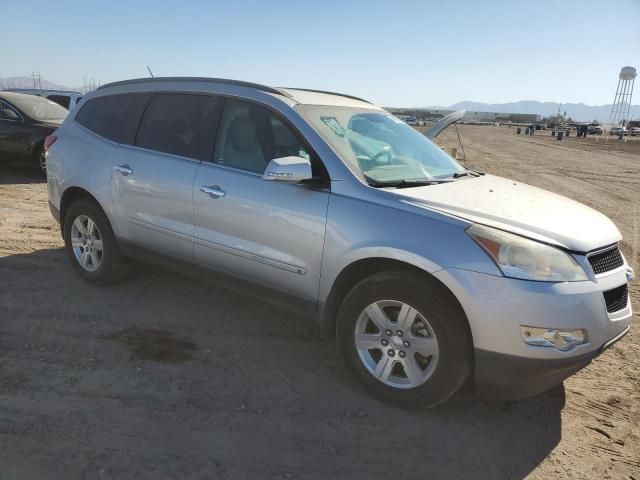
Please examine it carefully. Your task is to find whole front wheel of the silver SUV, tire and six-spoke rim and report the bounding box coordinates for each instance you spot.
[336,271,472,409]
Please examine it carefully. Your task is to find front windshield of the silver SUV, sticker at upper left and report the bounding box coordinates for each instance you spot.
[296,105,465,183]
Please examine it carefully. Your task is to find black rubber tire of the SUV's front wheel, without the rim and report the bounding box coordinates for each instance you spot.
[336,271,473,409]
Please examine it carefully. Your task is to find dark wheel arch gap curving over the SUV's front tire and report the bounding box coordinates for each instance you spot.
[319,257,473,345]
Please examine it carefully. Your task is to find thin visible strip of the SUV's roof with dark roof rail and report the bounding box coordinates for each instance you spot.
[98,77,380,109]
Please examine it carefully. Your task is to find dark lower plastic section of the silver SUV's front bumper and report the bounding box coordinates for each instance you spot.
[475,327,629,400]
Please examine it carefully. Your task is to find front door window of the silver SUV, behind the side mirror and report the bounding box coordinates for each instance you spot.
[214,100,311,173]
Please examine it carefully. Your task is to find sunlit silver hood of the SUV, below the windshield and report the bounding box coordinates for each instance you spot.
[394,175,622,252]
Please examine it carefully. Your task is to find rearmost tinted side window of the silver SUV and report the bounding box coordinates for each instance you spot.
[76,93,151,145]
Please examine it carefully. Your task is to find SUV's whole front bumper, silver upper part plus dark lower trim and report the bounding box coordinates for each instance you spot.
[434,265,632,399]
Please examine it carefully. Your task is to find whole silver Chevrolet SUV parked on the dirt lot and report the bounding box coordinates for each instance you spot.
[46,78,633,408]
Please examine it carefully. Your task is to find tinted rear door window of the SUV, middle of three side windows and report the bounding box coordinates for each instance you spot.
[136,93,222,161]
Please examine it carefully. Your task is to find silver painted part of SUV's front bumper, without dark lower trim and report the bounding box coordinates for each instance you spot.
[433,265,632,360]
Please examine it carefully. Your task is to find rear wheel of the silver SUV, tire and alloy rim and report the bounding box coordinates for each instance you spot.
[64,198,129,285]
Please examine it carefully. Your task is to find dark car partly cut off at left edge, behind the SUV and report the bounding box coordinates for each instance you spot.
[0,92,69,171]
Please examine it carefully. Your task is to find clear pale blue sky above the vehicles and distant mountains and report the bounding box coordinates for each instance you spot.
[0,0,640,106]
